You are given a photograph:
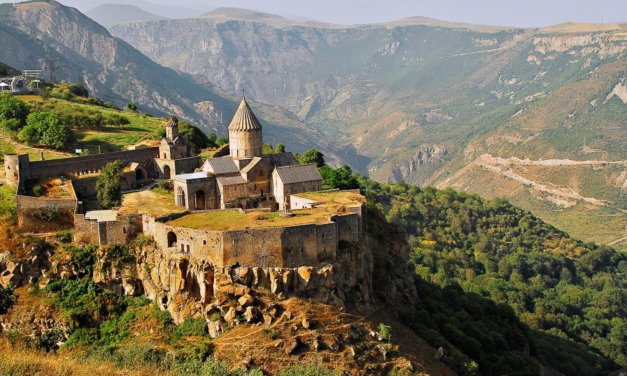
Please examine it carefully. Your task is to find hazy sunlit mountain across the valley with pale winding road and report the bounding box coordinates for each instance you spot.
[112,9,627,250]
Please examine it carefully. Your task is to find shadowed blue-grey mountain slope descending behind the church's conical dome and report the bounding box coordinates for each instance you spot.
[0,1,352,160]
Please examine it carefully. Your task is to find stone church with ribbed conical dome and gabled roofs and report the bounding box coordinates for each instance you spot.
[173,98,322,211]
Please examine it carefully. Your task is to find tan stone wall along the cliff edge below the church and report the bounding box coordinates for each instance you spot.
[143,207,364,267]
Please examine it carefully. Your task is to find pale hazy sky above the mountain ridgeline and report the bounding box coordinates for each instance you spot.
[35,0,627,27]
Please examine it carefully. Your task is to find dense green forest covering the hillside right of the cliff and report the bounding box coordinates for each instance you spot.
[359,177,627,375]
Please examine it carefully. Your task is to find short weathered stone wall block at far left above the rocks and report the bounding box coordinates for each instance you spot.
[16,195,77,232]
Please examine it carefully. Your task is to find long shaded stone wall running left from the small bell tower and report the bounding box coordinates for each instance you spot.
[28,147,159,179]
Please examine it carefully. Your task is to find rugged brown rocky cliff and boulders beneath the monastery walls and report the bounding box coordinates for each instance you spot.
[0,209,453,375]
